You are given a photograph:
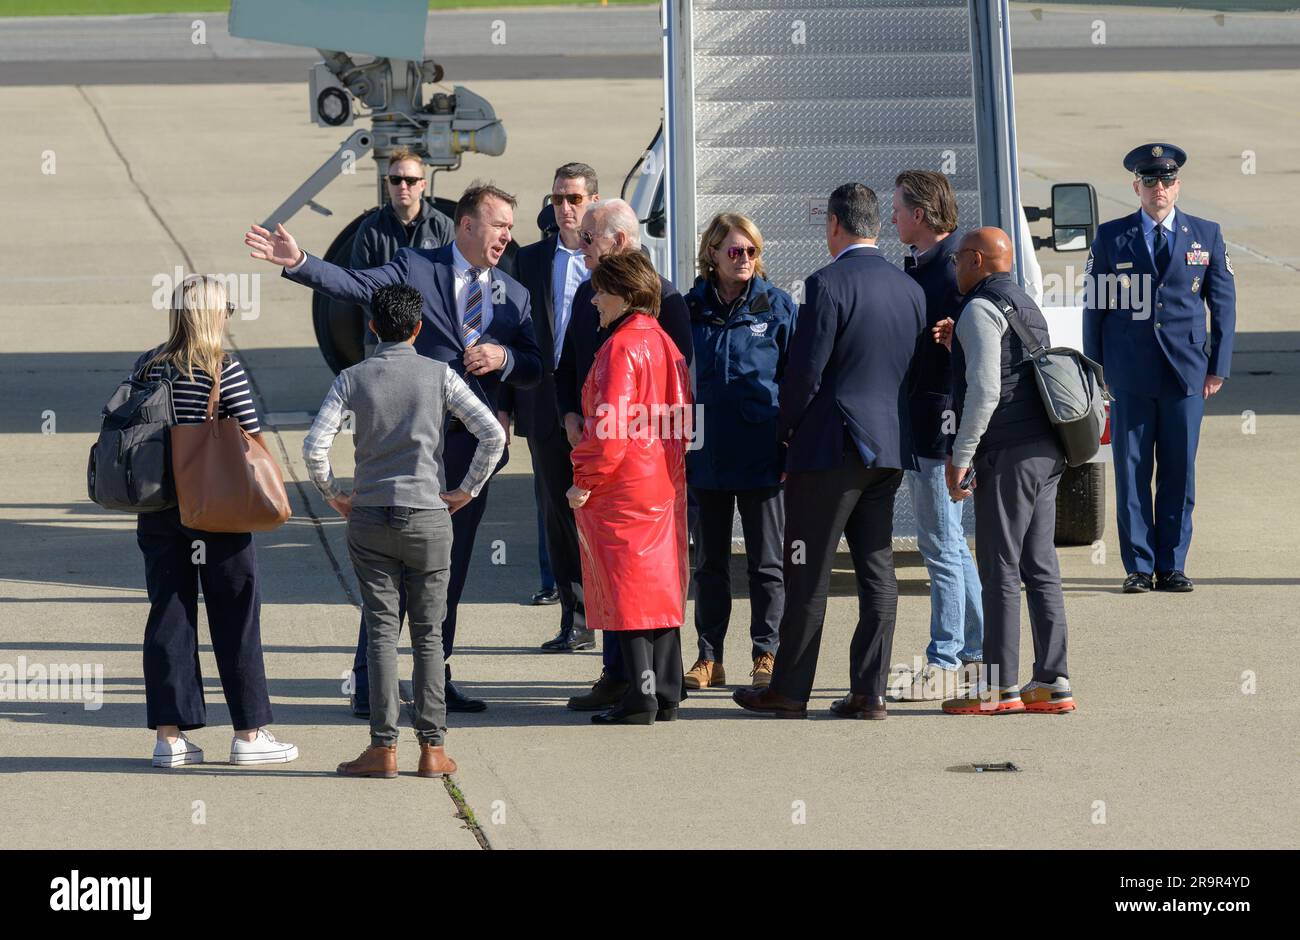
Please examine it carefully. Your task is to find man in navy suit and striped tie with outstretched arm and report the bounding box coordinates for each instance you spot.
[244,183,542,711]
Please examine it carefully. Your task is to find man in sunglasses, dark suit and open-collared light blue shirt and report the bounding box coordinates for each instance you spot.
[512,163,601,653]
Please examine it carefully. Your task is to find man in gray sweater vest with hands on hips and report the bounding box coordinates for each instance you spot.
[303,285,506,777]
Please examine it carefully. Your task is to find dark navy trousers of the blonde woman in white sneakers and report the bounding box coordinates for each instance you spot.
[135,508,270,731]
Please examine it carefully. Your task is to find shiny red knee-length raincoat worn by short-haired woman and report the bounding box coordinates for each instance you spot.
[572,313,692,631]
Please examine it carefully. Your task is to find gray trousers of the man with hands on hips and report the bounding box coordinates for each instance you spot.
[347,506,451,746]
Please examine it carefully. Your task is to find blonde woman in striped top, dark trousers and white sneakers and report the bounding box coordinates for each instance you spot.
[135,274,298,767]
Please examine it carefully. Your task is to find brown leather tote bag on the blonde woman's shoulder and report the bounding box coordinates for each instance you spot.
[172,374,290,532]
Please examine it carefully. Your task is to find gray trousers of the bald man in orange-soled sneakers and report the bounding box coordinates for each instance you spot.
[974,437,1069,688]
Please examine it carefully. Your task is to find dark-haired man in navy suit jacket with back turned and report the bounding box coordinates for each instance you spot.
[732,183,926,719]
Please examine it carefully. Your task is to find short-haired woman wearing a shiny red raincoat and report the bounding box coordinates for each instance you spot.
[568,251,692,724]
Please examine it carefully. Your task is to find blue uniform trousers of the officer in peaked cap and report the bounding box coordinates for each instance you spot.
[1110,382,1205,575]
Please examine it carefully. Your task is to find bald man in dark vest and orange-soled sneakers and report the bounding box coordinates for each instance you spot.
[935,228,1075,715]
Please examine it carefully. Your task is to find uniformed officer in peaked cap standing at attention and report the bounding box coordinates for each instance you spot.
[1083,143,1236,594]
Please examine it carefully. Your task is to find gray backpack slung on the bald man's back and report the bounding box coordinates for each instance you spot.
[1002,304,1106,467]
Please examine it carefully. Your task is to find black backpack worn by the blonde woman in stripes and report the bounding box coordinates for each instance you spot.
[86,354,178,512]
